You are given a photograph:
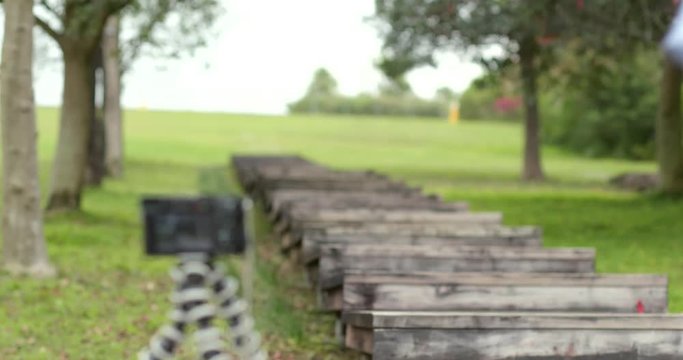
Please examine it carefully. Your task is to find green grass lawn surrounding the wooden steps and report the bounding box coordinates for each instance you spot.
[0,109,683,359]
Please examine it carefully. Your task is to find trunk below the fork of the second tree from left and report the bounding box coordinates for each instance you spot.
[47,47,92,211]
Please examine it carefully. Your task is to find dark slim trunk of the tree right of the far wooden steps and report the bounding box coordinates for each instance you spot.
[519,38,544,181]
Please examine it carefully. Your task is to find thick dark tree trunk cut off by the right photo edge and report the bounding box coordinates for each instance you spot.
[657,57,683,194]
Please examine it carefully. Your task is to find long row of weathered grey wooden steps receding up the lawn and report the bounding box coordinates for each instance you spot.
[232,156,683,360]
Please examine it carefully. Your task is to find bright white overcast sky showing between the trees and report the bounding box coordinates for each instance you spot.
[25,0,481,114]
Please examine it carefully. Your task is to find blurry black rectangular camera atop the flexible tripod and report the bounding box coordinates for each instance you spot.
[142,196,249,255]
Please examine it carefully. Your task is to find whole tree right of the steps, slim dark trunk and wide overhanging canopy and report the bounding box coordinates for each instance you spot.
[376,0,675,180]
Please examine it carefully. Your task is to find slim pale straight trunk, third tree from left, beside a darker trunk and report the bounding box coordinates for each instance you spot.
[102,16,123,177]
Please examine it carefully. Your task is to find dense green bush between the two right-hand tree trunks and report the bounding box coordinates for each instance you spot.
[544,51,660,159]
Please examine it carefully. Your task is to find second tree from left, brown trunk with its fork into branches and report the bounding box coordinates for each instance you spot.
[35,0,133,210]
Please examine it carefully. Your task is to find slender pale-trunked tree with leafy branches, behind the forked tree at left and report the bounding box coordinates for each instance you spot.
[96,0,223,177]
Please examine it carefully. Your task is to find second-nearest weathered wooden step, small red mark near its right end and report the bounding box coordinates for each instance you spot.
[334,273,668,313]
